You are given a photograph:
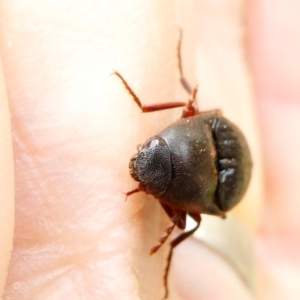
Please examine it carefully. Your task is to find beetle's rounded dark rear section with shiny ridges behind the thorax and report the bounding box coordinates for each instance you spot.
[213,117,252,211]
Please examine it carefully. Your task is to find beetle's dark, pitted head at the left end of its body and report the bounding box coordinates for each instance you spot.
[129,136,172,197]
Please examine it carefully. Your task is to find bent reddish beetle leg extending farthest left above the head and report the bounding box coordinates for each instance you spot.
[112,71,186,112]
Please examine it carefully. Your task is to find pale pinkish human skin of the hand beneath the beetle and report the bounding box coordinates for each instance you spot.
[0,0,300,300]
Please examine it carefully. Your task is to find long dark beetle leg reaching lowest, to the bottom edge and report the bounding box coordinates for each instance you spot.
[164,213,201,299]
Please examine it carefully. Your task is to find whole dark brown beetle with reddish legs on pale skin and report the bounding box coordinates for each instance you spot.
[113,32,252,298]
